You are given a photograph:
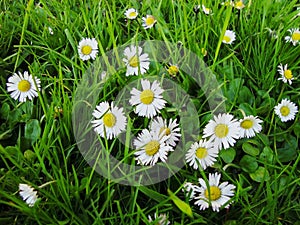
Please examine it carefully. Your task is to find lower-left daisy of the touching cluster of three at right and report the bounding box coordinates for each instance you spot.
[185,140,219,170]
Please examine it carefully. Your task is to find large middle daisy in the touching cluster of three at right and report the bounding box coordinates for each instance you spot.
[203,113,240,150]
